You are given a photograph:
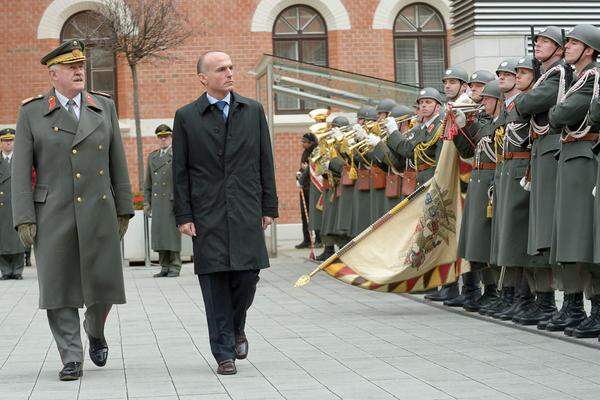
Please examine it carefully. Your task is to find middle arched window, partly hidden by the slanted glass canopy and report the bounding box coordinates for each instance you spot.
[273,5,328,112]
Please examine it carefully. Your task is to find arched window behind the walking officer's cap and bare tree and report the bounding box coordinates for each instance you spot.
[60,11,117,100]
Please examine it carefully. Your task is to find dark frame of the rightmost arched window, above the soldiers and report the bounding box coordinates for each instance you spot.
[392,3,448,88]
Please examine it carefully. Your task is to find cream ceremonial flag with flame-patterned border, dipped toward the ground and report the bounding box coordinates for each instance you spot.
[296,141,466,293]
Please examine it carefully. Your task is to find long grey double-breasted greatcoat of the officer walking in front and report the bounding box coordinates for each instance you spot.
[12,90,133,309]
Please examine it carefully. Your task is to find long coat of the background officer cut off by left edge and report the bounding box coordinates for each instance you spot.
[0,158,25,255]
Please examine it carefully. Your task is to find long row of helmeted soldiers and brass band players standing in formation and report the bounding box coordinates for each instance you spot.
[296,25,600,338]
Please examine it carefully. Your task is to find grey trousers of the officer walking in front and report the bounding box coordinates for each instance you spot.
[46,303,112,364]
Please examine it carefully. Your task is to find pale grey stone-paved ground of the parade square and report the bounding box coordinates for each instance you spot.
[0,250,600,400]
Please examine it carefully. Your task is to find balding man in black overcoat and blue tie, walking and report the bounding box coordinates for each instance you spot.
[173,51,278,375]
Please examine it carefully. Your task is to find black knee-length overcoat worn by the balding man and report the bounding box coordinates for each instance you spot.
[173,93,277,274]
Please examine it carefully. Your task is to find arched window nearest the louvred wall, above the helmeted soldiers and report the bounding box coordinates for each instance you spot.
[394,3,446,89]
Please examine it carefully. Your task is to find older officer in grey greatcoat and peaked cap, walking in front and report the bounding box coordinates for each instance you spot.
[12,40,133,380]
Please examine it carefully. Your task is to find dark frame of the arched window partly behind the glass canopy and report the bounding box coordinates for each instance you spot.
[271,4,329,114]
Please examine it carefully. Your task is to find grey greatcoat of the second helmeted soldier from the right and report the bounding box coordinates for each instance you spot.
[514,61,569,254]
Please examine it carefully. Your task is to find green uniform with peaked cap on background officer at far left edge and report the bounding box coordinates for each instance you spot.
[0,128,25,280]
